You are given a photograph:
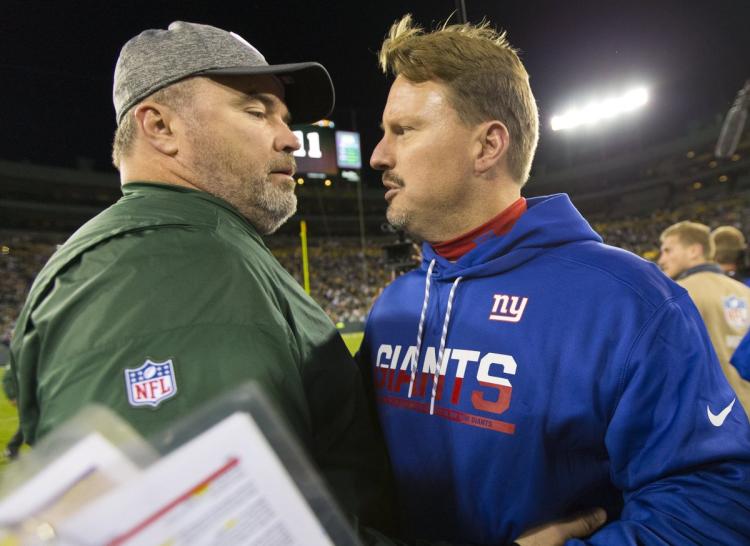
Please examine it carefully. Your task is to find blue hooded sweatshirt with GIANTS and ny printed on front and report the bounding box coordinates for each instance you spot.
[359,195,750,545]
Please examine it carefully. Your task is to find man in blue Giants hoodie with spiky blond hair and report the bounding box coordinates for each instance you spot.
[360,16,750,545]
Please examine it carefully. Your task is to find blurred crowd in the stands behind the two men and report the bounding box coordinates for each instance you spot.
[0,191,750,345]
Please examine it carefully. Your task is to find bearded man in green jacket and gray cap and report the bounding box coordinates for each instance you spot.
[11,22,385,521]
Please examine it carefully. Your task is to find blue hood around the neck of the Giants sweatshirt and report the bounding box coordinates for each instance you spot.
[421,193,602,279]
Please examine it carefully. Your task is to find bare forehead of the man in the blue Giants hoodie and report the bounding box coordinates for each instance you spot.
[383,76,455,120]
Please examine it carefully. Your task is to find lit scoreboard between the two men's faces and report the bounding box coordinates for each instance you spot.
[292,120,362,182]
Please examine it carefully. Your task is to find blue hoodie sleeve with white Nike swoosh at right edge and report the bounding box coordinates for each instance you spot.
[567,294,750,546]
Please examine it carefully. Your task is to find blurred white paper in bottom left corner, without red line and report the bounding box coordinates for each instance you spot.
[0,432,139,526]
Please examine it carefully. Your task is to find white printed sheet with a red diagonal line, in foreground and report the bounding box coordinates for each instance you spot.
[57,413,332,546]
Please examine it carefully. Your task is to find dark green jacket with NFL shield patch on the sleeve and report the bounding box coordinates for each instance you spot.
[11,183,394,521]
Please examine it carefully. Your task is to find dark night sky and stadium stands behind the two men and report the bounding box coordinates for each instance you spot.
[0,0,750,464]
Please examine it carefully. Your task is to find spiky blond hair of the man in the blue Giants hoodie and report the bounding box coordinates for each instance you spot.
[380,14,539,185]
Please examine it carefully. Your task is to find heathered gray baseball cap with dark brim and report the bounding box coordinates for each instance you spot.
[112,21,335,125]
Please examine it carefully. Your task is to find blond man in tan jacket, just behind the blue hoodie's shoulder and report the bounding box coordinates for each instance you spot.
[659,221,750,415]
